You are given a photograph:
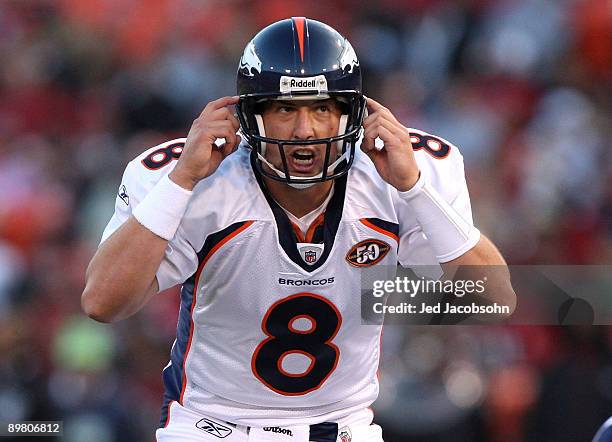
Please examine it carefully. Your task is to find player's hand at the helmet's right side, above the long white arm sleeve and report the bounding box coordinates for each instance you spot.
[361,97,419,192]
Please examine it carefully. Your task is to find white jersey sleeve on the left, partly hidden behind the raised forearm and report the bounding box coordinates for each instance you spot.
[100,141,198,291]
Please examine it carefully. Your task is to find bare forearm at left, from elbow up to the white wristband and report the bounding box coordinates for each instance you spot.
[81,217,168,322]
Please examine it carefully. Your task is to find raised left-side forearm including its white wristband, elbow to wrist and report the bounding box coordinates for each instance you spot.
[81,171,192,322]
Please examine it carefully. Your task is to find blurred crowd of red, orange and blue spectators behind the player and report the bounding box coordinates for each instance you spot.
[0,0,612,442]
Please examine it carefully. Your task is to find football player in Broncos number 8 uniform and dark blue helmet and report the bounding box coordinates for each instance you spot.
[82,17,509,442]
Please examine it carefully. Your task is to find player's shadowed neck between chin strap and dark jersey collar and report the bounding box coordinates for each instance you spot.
[264,177,333,218]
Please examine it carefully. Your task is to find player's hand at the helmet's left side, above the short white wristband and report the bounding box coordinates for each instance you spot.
[170,96,241,190]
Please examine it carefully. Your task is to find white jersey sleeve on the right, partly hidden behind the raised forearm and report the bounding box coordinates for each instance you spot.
[396,131,479,267]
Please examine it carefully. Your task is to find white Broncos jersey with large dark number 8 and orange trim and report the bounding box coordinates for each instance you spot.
[102,129,478,427]
